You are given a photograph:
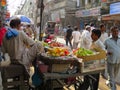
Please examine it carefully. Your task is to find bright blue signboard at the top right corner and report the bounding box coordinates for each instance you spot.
[110,2,120,14]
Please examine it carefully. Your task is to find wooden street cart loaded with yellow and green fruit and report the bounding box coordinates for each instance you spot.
[38,41,106,90]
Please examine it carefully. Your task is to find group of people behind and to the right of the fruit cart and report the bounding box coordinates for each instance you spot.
[65,23,120,90]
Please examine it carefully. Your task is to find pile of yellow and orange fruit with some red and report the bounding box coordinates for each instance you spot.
[47,47,70,57]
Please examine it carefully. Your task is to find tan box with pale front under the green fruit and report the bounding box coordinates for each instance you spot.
[78,51,106,73]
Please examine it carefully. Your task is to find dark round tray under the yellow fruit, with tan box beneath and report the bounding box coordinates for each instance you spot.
[38,53,78,72]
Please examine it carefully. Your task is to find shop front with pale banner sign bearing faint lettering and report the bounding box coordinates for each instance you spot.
[75,7,101,29]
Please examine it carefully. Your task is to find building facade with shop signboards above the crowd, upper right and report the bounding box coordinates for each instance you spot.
[75,0,120,29]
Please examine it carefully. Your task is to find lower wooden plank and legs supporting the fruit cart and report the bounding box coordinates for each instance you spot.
[38,68,104,90]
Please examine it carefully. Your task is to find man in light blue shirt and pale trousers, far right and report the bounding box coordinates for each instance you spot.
[104,26,120,90]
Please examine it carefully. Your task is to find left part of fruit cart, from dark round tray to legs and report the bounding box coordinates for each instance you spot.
[38,53,80,90]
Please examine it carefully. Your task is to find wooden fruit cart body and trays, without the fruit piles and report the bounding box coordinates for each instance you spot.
[38,51,106,90]
